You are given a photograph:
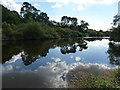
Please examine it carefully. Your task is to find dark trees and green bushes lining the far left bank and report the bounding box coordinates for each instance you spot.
[1,2,109,40]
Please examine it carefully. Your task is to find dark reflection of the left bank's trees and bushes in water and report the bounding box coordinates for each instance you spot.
[2,39,87,65]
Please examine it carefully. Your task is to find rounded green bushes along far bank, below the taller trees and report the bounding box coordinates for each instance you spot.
[2,22,83,40]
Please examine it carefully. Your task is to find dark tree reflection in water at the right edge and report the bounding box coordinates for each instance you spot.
[108,42,120,65]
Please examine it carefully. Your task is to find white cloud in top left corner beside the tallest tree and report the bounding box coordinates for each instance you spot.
[0,0,22,12]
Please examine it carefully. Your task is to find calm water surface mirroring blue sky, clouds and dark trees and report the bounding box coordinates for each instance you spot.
[0,38,120,88]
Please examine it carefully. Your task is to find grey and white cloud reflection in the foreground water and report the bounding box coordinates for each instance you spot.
[2,61,115,88]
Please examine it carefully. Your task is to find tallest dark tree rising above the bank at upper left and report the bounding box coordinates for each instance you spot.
[20,2,49,23]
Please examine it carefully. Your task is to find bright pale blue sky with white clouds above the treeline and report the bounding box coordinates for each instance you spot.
[0,0,119,31]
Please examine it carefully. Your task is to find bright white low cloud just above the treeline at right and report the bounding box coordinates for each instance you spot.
[50,15,112,31]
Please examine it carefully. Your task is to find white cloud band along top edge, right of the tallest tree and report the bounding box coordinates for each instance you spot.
[48,0,119,11]
